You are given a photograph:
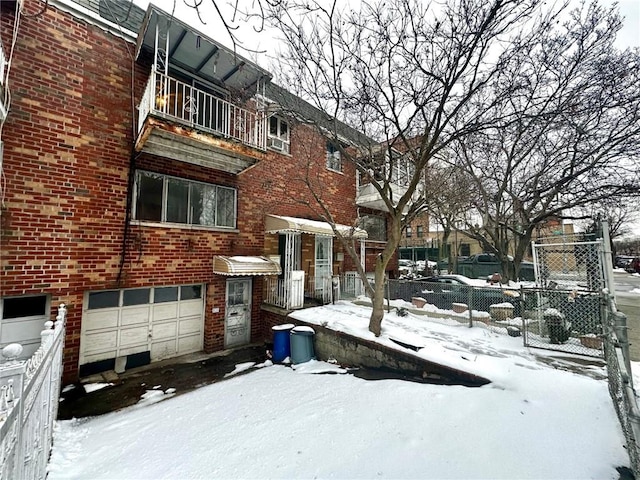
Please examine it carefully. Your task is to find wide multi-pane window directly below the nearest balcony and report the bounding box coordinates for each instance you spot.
[134,171,237,228]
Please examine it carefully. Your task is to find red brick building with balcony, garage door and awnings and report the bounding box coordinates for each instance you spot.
[0,0,386,382]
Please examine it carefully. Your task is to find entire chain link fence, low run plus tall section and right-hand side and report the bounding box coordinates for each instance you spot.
[387,225,640,472]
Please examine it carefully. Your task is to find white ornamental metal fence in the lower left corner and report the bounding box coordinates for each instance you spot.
[0,304,67,480]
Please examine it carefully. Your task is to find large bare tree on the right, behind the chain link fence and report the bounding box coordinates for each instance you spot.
[451,3,640,275]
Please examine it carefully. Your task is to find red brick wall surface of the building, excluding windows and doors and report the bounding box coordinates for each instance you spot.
[0,1,378,381]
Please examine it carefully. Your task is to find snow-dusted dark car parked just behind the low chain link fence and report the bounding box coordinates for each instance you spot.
[396,274,520,316]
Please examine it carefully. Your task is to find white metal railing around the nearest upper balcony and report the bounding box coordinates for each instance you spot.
[138,71,266,150]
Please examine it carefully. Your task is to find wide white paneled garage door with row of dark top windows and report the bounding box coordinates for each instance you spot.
[80,285,204,365]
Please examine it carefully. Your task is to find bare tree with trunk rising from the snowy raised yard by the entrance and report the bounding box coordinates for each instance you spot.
[264,0,592,335]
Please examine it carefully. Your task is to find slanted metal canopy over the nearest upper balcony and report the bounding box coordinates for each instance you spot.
[136,5,271,96]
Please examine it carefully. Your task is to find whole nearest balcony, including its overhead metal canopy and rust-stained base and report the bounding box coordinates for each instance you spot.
[135,5,271,174]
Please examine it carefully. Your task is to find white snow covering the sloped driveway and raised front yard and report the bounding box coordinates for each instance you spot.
[48,302,629,480]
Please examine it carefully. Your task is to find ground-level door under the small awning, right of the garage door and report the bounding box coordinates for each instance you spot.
[224,278,251,348]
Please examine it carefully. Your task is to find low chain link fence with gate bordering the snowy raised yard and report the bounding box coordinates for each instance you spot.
[388,275,603,357]
